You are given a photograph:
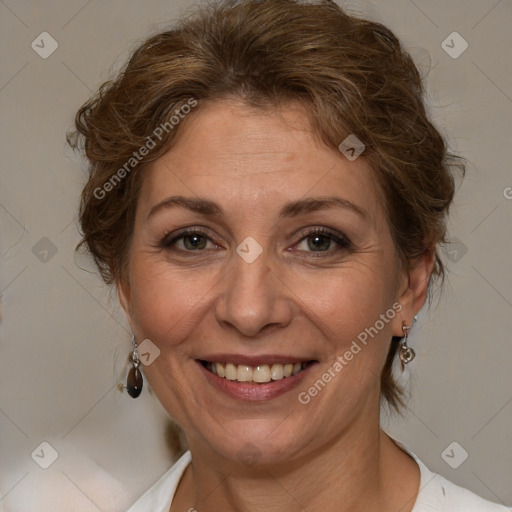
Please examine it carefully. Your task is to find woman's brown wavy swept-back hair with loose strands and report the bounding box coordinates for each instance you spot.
[68,0,464,409]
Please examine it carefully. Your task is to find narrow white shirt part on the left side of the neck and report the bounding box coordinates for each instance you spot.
[127,452,191,512]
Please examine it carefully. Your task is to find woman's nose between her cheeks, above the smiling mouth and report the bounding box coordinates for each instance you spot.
[215,246,293,338]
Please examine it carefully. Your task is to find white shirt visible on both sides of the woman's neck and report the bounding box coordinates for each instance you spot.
[127,450,512,512]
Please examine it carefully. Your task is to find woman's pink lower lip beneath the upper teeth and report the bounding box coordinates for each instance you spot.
[197,361,315,402]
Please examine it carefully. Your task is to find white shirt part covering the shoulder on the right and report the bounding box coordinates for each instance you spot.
[412,457,512,512]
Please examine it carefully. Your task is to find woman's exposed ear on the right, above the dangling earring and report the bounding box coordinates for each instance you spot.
[392,246,435,337]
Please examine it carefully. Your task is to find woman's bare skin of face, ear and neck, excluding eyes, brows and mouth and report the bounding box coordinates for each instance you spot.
[118,100,433,512]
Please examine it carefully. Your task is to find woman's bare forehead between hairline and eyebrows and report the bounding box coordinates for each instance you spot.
[139,101,382,219]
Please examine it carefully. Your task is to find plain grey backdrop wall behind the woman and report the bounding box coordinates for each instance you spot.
[0,0,512,512]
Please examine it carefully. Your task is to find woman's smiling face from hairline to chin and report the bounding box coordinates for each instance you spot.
[119,101,419,462]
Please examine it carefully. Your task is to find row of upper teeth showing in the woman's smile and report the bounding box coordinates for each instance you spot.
[206,363,306,383]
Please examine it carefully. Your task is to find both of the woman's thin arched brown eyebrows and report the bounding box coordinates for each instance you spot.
[146,196,369,220]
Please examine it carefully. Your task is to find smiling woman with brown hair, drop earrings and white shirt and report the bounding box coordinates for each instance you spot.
[69,0,506,512]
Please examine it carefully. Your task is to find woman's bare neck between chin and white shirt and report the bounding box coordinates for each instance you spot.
[176,414,419,512]
